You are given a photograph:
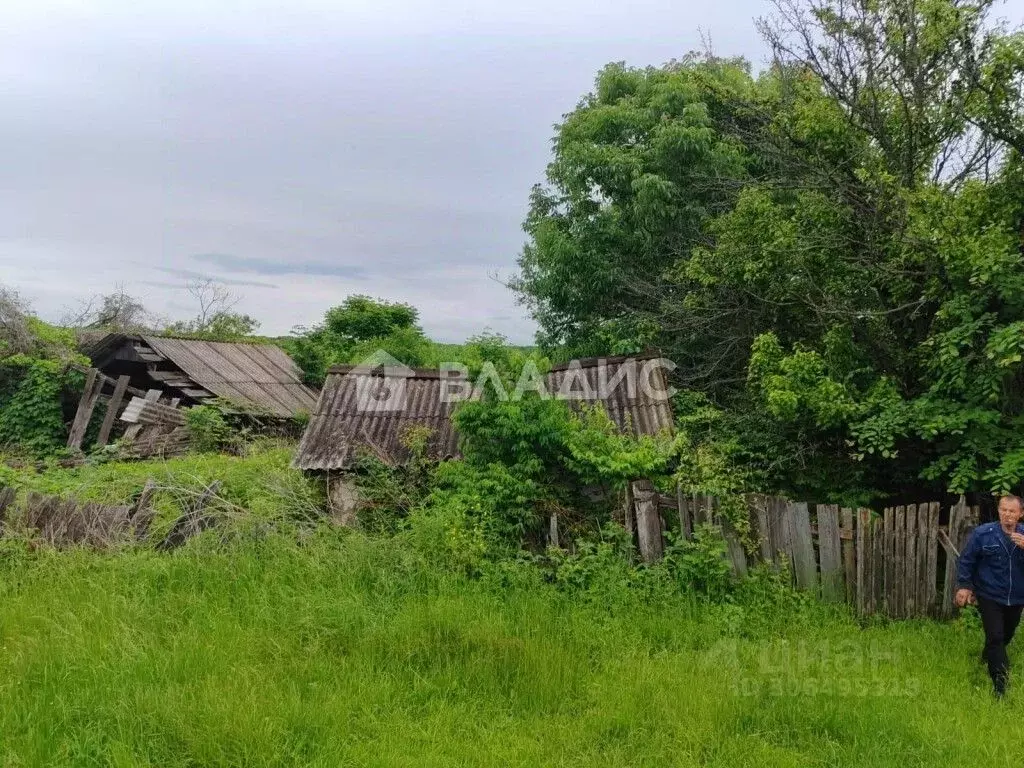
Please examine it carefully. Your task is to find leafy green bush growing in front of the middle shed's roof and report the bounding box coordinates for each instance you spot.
[418,394,672,567]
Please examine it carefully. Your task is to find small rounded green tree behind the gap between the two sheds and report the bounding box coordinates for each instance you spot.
[292,295,431,386]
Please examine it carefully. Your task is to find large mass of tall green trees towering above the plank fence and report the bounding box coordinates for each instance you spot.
[517,0,1024,503]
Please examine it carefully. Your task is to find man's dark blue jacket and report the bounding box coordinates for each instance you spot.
[956,522,1024,605]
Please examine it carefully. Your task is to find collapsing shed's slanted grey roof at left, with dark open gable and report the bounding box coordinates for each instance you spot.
[83,334,316,419]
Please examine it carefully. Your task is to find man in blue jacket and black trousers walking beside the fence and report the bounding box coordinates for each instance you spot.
[955,496,1024,697]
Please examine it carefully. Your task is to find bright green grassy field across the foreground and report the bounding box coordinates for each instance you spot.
[0,531,1024,768]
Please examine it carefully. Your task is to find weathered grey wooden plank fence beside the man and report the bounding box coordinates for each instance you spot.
[628,490,980,618]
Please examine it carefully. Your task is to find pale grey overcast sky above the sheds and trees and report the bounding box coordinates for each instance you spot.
[0,0,782,343]
